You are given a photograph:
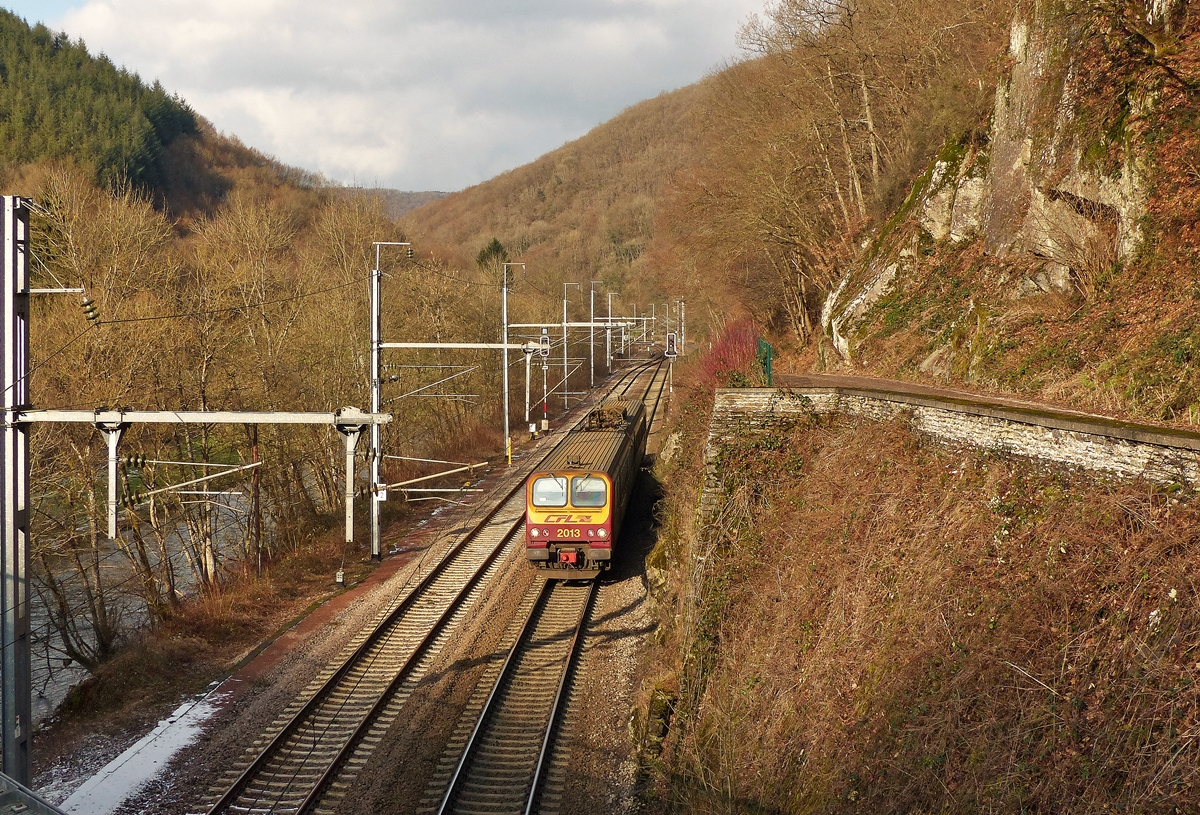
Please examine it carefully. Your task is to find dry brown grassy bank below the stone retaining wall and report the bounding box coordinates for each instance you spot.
[643,421,1200,813]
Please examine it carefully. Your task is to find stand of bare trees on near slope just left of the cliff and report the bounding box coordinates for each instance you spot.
[656,0,1010,343]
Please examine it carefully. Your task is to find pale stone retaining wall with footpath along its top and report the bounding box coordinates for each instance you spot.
[702,376,1200,503]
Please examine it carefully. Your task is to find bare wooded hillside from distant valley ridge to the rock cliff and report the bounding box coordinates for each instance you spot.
[406,0,1010,342]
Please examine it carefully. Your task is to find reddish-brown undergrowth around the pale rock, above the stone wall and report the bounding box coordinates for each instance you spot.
[802,2,1200,425]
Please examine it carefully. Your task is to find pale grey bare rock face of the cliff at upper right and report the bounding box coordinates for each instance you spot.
[822,0,1181,367]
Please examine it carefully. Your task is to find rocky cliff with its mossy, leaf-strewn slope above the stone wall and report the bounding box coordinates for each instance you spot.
[804,0,1200,425]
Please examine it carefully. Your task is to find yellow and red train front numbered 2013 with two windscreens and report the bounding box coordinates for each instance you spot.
[526,471,613,580]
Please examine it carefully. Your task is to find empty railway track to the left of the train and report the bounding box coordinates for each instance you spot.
[196,362,661,815]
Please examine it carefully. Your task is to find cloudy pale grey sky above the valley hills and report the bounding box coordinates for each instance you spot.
[0,0,764,191]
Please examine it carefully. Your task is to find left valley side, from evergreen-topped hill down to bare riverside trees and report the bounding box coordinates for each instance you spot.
[0,12,516,707]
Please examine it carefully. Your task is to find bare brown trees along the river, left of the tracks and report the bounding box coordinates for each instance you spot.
[25,160,520,669]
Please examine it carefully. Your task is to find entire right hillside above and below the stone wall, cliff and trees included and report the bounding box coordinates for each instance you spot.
[640,0,1200,815]
